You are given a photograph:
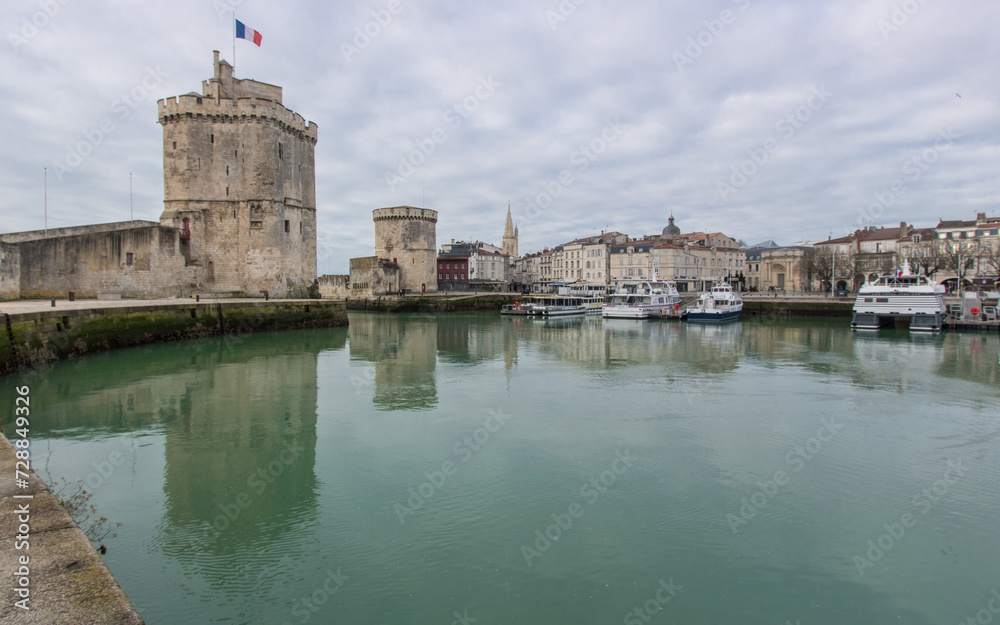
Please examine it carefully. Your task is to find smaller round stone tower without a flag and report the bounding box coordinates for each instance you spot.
[372,206,437,293]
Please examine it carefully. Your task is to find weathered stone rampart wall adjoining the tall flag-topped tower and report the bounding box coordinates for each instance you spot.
[12,222,201,298]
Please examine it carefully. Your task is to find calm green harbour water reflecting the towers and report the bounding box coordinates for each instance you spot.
[0,314,1000,625]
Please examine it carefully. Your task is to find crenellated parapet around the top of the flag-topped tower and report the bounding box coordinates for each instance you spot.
[156,93,319,145]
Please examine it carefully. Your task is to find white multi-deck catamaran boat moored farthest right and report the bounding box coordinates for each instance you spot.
[851,263,948,332]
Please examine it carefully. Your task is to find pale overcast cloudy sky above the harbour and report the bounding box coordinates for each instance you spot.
[0,0,1000,273]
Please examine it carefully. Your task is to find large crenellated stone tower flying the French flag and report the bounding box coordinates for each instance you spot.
[157,51,317,297]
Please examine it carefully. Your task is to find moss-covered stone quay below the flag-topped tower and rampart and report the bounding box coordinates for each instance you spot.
[0,299,347,375]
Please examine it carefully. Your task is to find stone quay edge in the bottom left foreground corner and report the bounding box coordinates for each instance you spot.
[0,433,143,625]
